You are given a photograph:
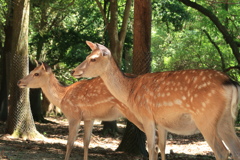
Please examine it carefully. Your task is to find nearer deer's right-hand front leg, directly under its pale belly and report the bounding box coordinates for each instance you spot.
[157,127,167,160]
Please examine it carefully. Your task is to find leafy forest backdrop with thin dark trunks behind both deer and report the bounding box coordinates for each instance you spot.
[0,0,240,159]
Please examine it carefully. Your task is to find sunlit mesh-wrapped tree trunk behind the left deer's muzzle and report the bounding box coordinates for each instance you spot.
[6,0,42,139]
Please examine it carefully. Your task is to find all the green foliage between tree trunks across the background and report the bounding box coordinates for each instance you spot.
[0,0,240,84]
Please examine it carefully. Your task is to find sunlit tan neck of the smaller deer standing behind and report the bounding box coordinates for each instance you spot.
[42,74,67,108]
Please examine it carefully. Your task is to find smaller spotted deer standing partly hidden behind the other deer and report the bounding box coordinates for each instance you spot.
[18,63,143,160]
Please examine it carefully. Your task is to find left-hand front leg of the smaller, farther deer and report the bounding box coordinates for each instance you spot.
[65,120,80,160]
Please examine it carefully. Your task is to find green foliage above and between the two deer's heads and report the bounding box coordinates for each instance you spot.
[30,0,104,84]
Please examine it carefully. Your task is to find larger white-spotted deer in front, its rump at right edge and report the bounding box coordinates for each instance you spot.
[72,41,240,160]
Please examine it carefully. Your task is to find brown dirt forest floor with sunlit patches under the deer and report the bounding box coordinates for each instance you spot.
[0,117,240,160]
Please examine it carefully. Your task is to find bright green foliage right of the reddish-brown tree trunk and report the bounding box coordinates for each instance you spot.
[152,0,240,79]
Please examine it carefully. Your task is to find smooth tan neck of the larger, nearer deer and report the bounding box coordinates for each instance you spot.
[101,58,131,105]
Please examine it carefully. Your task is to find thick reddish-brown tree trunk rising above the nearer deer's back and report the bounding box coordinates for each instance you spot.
[133,0,152,74]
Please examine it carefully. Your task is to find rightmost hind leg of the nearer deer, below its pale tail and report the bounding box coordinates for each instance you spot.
[218,111,240,160]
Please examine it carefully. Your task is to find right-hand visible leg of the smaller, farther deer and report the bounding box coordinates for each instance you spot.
[84,121,94,160]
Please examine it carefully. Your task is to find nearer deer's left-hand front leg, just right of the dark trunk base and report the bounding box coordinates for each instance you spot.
[143,120,158,160]
